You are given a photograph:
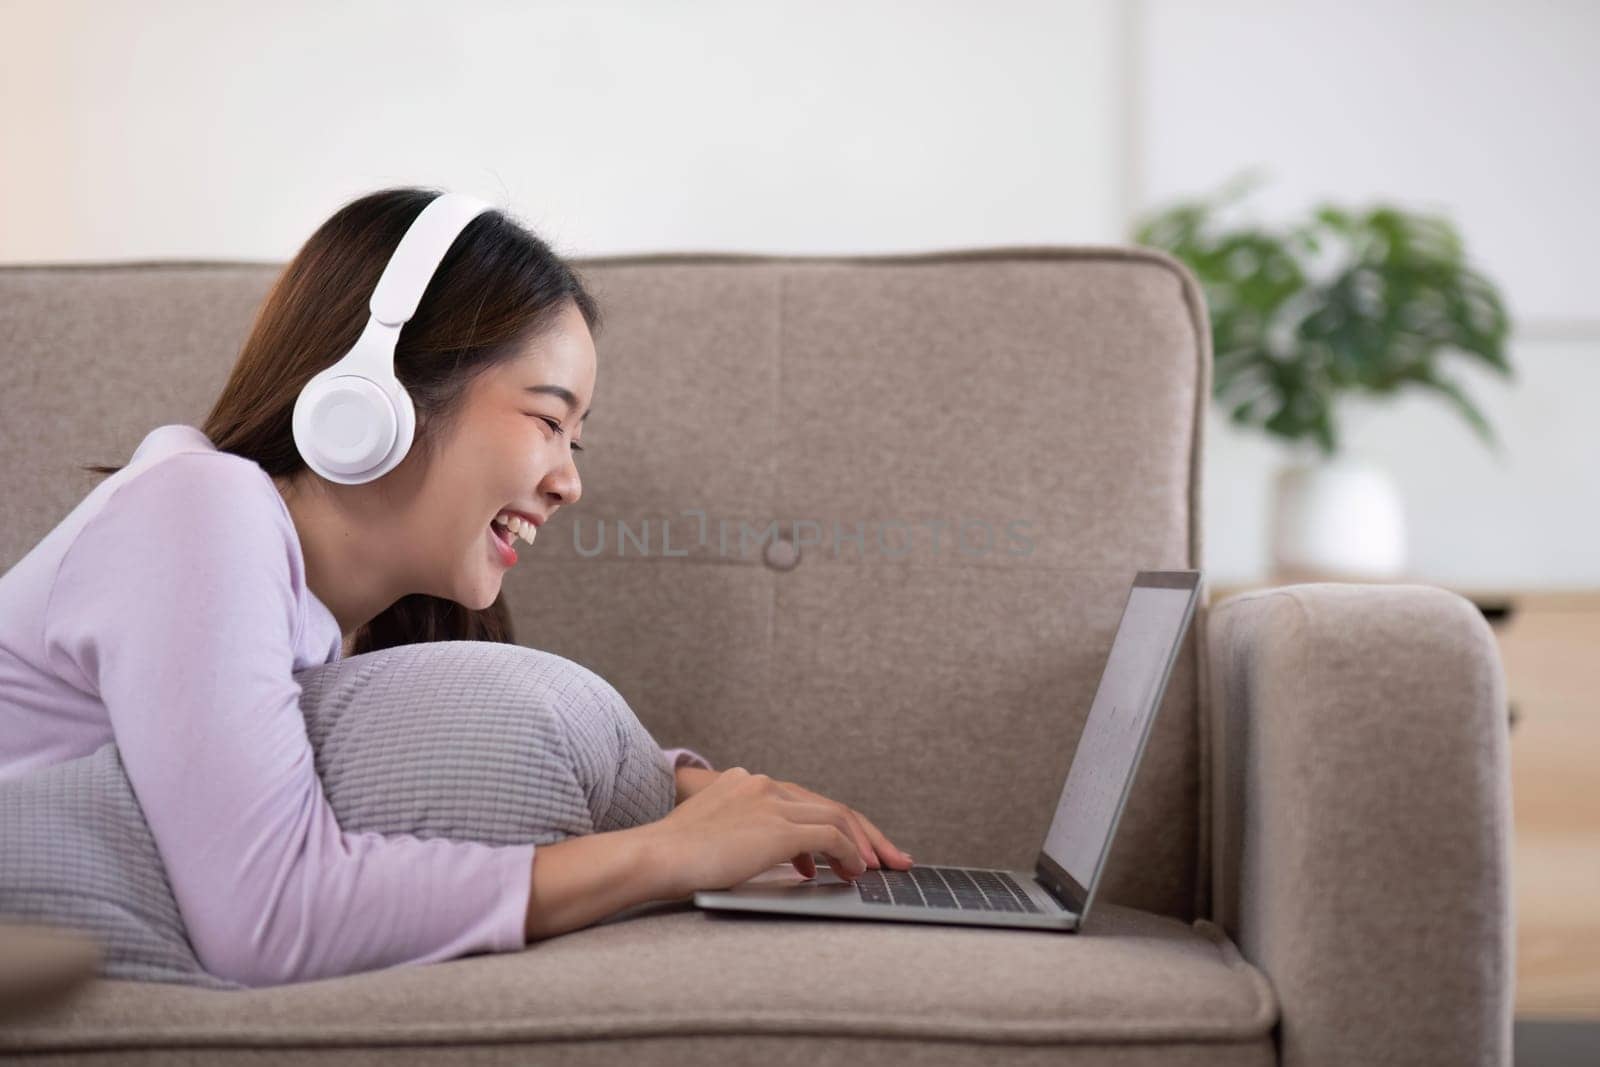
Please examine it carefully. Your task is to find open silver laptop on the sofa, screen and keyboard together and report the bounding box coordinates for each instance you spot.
[694,571,1200,933]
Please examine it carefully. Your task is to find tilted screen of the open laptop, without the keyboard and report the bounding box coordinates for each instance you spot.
[1045,571,1198,910]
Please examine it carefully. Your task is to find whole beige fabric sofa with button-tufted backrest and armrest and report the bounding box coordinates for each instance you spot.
[0,248,1512,1065]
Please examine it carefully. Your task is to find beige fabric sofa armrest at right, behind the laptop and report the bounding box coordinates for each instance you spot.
[1205,582,1514,1067]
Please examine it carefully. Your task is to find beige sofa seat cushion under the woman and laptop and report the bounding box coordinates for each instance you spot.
[0,901,1277,1064]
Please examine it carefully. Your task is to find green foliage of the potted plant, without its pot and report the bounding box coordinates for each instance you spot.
[1134,173,1512,453]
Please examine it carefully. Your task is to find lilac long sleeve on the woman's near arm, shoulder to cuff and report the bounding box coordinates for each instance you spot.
[43,453,534,985]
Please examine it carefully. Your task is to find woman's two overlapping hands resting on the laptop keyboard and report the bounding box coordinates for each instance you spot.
[648,766,912,896]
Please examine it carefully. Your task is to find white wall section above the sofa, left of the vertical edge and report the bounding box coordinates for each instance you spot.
[0,0,1123,261]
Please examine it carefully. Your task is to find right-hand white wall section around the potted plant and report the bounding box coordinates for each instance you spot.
[1128,0,1600,589]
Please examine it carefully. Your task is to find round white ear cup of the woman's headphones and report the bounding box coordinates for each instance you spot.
[294,368,414,485]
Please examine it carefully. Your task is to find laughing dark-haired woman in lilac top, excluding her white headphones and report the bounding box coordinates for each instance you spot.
[0,181,910,984]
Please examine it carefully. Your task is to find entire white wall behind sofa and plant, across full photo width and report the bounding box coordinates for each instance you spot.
[0,0,1600,587]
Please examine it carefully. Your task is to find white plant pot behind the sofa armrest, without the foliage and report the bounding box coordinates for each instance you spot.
[1272,456,1406,581]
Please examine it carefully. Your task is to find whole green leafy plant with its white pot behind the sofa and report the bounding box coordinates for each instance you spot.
[1134,174,1512,581]
